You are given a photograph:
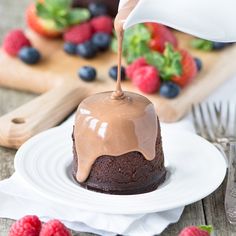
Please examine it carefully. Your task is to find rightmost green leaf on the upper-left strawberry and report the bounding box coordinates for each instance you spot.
[67,8,90,25]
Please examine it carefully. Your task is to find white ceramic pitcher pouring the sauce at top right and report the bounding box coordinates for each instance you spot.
[119,0,236,42]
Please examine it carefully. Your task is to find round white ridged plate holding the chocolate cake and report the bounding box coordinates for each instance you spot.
[15,127,226,214]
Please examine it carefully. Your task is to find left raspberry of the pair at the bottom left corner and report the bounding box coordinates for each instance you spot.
[8,215,41,236]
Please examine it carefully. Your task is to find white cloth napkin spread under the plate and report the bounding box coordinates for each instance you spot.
[0,77,236,236]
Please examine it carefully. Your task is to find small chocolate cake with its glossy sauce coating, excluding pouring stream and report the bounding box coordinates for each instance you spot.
[72,92,166,194]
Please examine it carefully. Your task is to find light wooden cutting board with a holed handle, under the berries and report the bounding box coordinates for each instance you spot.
[0,29,236,148]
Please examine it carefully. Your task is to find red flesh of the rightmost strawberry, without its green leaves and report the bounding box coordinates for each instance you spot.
[171,49,197,87]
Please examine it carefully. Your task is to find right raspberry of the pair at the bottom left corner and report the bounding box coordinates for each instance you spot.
[40,220,71,236]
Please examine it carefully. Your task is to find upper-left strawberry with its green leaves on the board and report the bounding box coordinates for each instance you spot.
[26,0,90,38]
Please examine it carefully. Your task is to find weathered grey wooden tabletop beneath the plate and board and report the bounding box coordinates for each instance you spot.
[0,0,236,236]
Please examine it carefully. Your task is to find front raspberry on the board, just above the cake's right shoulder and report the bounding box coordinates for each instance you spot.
[133,66,160,93]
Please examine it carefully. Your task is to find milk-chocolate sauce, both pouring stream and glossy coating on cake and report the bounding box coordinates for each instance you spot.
[74,0,159,182]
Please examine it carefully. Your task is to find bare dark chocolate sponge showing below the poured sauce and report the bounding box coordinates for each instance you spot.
[73,116,166,195]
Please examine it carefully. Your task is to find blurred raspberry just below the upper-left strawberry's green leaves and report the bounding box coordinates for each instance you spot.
[63,23,92,44]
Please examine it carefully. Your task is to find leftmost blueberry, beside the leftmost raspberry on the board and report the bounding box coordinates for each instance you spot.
[18,47,41,65]
